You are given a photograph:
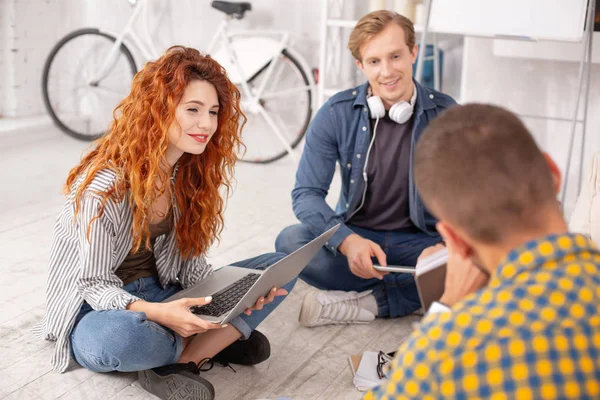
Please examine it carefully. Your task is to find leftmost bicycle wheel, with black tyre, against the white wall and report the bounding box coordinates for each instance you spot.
[42,29,137,140]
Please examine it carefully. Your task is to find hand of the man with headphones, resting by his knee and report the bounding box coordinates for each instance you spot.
[338,233,388,279]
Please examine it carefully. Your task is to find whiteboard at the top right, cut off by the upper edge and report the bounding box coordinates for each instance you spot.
[429,0,588,42]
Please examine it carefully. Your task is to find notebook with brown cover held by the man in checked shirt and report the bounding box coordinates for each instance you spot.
[415,248,448,312]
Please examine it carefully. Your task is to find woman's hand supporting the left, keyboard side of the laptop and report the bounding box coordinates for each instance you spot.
[127,297,227,337]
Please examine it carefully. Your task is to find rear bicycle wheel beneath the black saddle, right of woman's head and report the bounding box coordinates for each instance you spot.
[238,50,312,164]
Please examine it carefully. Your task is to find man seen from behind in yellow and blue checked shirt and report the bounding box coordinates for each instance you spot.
[366,104,600,400]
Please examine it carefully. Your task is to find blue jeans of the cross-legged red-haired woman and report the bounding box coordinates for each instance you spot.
[71,253,296,372]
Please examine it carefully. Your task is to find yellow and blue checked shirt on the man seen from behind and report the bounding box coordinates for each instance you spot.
[365,234,600,400]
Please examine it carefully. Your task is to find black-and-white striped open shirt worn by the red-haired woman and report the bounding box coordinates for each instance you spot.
[33,169,212,372]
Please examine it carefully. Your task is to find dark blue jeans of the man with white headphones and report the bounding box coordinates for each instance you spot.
[275,224,441,317]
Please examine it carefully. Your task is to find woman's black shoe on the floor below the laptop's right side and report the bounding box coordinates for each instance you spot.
[212,331,271,365]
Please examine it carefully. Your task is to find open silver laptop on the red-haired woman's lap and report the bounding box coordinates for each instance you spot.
[163,224,340,325]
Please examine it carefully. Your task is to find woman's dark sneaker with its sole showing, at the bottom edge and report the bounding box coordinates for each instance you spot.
[138,370,215,400]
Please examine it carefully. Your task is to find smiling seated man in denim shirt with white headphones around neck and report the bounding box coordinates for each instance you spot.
[275,10,455,326]
